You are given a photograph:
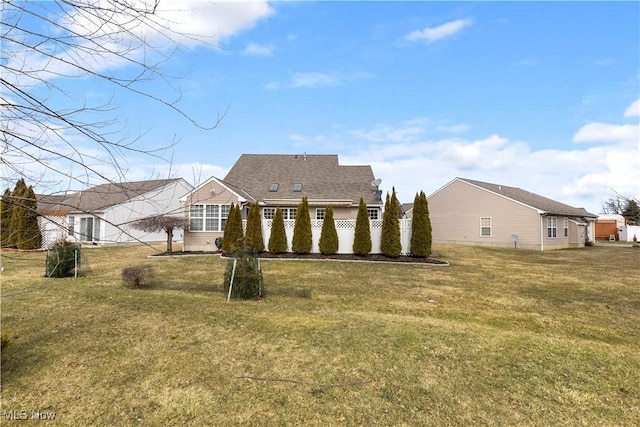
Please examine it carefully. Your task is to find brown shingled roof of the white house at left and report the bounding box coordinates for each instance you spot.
[37,178,180,215]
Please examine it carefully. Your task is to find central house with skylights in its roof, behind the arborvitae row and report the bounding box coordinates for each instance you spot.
[181,154,384,252]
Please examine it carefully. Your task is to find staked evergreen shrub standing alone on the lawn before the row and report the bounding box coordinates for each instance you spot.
[224,240,264,299]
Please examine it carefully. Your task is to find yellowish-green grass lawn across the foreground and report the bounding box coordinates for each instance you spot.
[1,244,640,426]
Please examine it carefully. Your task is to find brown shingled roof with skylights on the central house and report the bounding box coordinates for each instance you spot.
[224,154,382,205]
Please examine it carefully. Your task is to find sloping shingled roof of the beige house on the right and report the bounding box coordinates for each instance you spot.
[456,178,597,219]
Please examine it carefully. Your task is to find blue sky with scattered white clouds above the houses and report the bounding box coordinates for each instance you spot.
[5,0,640,213]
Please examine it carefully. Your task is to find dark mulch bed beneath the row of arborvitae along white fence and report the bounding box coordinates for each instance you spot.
[151,251,449,266]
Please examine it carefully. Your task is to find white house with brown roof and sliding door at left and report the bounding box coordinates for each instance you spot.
[37,178,193,248]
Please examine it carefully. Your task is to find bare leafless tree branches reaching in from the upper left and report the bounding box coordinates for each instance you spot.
[0,0,221,194]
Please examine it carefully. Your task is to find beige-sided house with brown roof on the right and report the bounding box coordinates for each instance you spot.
[428,178,597,251]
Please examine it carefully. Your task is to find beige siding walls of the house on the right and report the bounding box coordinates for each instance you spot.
[429,181,544,250]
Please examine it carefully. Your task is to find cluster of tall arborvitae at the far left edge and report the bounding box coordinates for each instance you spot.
[0,179,42,249]
